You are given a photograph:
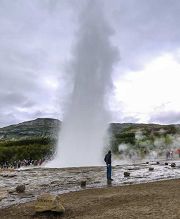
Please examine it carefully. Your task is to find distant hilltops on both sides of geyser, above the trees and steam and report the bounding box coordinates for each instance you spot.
[0,118,180,140]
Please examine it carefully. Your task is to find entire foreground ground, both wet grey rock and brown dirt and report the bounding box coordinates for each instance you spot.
[0,163,180,219]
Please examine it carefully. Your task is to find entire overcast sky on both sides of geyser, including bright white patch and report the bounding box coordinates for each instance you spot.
[0,0,180,127]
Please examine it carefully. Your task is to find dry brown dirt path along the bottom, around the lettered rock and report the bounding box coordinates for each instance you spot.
[0,180,180,219]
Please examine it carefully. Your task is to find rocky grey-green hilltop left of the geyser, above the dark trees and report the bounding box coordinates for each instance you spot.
[0,118,61,140]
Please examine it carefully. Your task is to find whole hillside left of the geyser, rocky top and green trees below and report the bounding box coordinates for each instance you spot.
[0,118,61,164]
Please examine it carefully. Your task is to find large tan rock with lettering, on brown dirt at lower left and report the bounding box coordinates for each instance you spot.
[35,194,65,213]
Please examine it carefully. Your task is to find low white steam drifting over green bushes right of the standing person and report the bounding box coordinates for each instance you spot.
[116,129,180,161]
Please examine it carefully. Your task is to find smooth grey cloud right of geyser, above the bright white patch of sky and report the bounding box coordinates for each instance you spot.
[109,0,180,72]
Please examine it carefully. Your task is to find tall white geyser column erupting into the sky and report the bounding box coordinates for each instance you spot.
[48,1,118,167]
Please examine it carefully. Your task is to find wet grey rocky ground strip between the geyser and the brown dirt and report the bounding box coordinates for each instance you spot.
[0,161,180,208]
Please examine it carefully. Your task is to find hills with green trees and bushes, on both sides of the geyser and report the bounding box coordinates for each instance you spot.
[0,118,180,163]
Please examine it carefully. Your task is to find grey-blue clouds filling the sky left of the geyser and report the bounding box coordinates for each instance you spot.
[0,0,74,126]
